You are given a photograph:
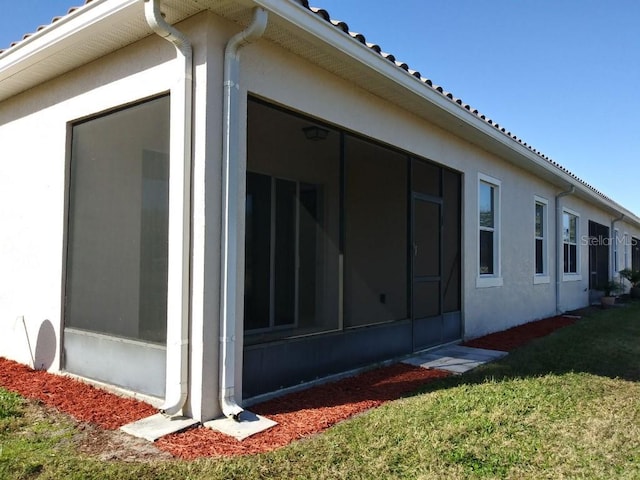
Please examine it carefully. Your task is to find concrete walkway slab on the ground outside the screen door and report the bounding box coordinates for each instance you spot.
[403,345,507,375]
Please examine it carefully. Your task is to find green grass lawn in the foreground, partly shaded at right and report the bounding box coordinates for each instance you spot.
[0,303,640,480]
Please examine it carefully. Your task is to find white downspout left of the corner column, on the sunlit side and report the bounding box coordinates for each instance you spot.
[144,0,193,415]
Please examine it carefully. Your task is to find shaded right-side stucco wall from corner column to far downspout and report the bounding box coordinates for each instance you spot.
[238,34,558,337]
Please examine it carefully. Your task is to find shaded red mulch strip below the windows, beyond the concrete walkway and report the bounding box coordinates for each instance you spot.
[463,315,576,352]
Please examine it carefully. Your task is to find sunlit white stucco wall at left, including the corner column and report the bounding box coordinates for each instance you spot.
[0,14,228,418]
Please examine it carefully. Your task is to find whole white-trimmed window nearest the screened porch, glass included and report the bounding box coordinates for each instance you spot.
[478,175,500,286]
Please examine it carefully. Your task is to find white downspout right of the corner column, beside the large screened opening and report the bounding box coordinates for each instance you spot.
[219,8,268,419]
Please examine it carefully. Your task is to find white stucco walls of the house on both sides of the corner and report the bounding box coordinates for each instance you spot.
[0,4,640,412]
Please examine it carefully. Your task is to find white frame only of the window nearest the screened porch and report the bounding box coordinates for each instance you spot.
[476,173,504,288]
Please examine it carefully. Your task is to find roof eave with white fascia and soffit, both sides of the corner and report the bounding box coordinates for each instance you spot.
[0,0,640,226]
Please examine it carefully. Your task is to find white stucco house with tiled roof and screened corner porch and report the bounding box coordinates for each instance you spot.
[0,0,640,420]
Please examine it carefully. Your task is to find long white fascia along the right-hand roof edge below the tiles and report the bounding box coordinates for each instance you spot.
[253,0,640,226]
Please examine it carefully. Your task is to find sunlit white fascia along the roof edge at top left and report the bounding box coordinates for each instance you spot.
[0,0,140,82]
